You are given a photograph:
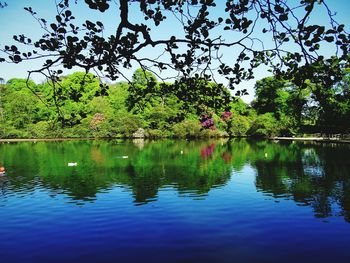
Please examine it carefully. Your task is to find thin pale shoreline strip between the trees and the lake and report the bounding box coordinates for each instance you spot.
[0,137,350,143]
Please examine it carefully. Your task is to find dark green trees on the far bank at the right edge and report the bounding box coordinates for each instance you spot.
[252,71,350,135]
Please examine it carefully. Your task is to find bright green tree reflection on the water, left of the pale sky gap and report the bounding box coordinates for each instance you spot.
[0,141,235,203]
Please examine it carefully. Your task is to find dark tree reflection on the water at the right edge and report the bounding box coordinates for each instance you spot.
[251,142,350,222]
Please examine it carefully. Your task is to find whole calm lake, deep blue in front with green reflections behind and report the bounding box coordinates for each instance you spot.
[0,139,350,263]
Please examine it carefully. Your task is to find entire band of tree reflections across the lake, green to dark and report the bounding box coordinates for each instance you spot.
[0,139,350,222]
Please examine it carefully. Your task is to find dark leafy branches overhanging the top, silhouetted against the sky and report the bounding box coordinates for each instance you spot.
[0,0,349,91]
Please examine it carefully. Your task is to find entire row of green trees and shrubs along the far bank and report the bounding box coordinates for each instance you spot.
[0,69,350,138]
